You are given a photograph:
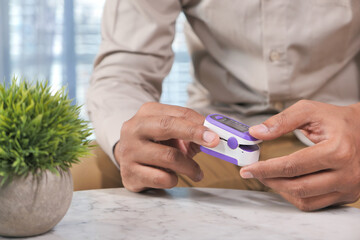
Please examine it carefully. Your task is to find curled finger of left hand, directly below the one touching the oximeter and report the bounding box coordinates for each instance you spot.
[134,142,204,182]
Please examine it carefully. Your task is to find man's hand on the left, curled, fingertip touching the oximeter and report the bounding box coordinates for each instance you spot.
[114,103,219,192]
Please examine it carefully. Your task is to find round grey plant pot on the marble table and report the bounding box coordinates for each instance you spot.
[0,171,73,237]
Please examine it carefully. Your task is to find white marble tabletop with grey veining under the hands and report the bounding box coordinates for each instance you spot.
[3,188,360,240]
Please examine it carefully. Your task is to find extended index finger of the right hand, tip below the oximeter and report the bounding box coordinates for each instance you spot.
[240,142,334,179]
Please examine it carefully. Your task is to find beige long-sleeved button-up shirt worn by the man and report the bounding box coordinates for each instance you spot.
[87,0,360,165]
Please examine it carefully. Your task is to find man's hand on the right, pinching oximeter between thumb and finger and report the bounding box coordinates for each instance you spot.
[240,100,360,211]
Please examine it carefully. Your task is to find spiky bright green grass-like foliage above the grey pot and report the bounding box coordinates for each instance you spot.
[0,78,91,186]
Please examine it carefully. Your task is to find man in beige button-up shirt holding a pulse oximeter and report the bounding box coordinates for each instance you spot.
[88,0,360,211]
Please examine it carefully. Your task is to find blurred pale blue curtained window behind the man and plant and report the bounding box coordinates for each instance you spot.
[0,0,191,119]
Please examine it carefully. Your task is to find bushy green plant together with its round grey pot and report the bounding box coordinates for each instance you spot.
[0,79,91,237]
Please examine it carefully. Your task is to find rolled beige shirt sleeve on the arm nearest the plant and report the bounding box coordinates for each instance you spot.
[87,0,181,166]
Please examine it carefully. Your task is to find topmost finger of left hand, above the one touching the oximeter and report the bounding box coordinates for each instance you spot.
[139,102,205,125]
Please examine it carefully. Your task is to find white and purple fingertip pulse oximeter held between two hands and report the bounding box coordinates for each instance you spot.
[200,114,262,166]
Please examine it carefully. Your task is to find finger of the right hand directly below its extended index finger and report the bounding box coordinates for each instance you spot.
[262,171,343,198]
